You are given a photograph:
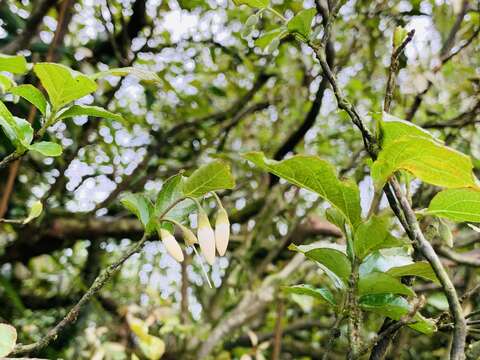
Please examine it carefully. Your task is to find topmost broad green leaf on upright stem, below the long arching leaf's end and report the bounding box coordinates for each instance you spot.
[353,216,404,259]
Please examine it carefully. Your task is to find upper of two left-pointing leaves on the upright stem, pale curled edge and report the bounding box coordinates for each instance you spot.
[288,244,352,288]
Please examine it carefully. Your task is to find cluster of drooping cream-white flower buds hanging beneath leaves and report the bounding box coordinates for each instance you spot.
[158,193,230,265]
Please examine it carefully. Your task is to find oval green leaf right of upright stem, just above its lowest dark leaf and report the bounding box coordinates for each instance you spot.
[358,272,415,296]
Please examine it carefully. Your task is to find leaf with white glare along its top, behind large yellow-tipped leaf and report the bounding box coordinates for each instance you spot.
[379,112,439,148]
